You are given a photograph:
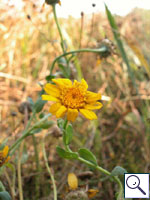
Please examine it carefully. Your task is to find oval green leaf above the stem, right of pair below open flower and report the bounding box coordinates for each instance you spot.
[78,148,97,165]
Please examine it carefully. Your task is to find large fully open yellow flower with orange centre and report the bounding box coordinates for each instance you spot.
[42,78,102,122]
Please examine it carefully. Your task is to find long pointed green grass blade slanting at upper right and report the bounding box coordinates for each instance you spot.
[105,4,137,92]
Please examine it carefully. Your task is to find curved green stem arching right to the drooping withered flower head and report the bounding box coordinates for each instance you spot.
[50,47,107,75]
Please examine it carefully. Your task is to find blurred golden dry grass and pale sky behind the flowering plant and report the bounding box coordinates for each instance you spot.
[0,0,150,200]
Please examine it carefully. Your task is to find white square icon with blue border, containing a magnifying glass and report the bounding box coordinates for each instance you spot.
[124,173,149,199]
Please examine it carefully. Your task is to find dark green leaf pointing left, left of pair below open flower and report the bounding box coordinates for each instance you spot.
[56,146,78,159]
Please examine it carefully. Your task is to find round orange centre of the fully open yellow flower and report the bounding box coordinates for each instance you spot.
[61,87,85,109]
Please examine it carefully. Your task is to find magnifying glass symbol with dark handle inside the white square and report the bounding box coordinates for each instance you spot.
[126,175,146,195]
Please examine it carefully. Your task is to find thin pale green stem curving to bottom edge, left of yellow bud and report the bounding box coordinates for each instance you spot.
[42,140,57,200]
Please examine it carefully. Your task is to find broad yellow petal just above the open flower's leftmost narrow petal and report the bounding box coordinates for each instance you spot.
[44,83,60,97]
